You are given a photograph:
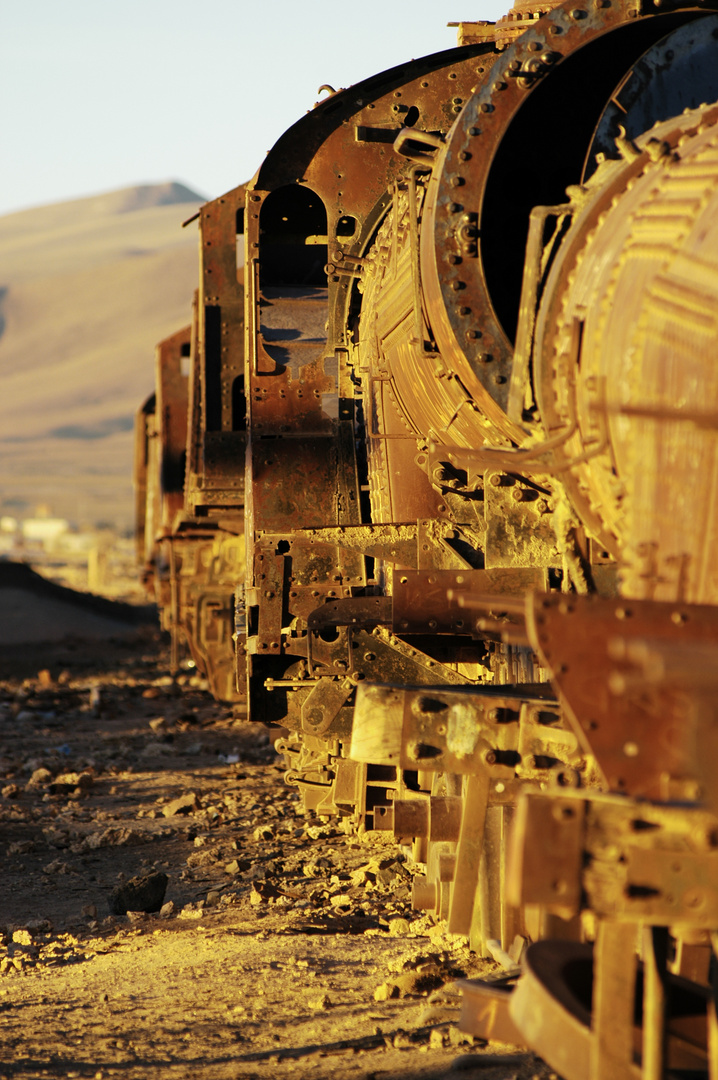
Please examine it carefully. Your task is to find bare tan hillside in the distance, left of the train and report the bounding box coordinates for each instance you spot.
[0,181,205,528]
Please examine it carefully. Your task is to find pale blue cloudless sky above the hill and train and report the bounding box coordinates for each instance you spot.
[5,0,511,214]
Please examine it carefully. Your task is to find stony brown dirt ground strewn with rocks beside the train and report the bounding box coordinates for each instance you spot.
[0,631,553,1080]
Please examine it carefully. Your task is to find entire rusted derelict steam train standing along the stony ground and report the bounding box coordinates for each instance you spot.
[138,0,718,1080]
